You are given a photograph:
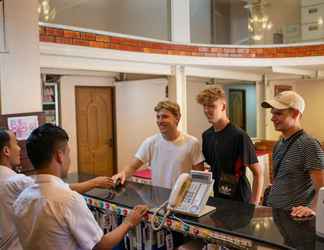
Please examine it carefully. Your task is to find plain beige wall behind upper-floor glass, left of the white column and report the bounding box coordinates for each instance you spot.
[51,0,170,40]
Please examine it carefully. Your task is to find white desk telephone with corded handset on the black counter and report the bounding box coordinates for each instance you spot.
[151,170,215,230]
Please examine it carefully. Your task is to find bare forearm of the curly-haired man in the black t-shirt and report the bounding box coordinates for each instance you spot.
[248,163,264,205]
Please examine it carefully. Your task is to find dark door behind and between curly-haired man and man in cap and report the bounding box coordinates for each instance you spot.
[228,89,246,130]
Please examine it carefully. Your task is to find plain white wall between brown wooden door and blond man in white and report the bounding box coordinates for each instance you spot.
[116,79,168,171]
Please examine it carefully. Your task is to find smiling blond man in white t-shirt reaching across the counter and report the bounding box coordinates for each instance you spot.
[113,101,204,188]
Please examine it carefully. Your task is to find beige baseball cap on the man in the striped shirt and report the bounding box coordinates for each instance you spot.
[261,90,305,114]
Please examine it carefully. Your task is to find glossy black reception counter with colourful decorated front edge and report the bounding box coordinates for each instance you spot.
[66,175,324,250]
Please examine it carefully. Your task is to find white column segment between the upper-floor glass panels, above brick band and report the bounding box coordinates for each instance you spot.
[171,0,190,43]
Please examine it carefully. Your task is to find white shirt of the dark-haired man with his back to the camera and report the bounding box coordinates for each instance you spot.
[13,175,103,250]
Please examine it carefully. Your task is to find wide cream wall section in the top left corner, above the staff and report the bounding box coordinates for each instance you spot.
[0,0,42,114]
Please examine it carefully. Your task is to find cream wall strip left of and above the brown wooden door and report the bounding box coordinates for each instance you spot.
[60,76,114,172]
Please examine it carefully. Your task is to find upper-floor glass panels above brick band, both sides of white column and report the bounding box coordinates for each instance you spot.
[39,0,324,45]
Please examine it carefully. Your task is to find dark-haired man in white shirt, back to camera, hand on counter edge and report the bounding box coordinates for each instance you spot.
[13,124,147,250]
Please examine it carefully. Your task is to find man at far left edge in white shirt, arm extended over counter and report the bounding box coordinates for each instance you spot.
[0,129,125,250]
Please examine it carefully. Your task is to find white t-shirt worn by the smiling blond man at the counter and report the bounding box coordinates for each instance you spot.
[135,133,204,188]
